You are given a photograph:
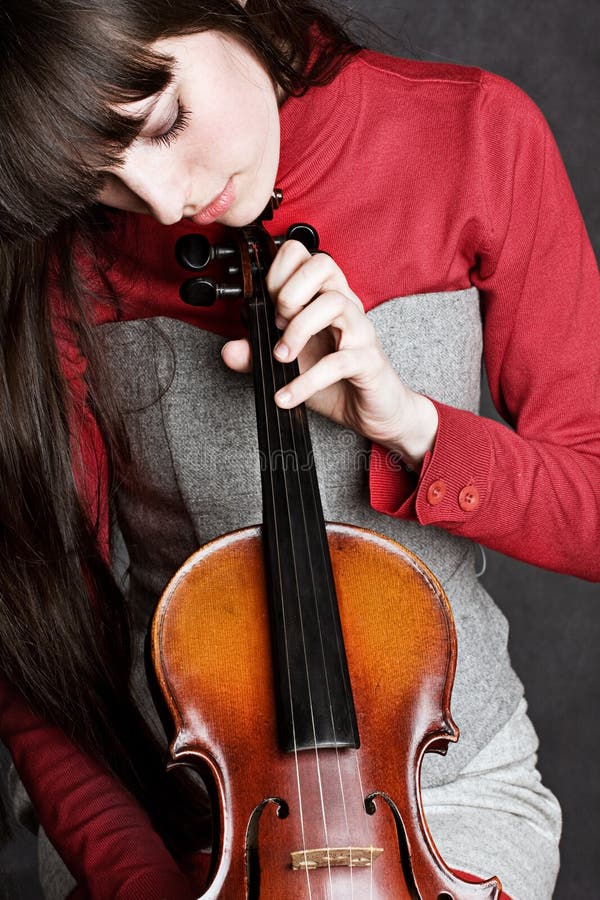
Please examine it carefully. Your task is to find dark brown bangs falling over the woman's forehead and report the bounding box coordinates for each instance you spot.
[0,7,172,242]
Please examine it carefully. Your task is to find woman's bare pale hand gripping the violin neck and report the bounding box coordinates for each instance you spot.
[222,241,438,469]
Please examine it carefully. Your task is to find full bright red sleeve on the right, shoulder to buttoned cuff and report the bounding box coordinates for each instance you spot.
[371,68,600,581]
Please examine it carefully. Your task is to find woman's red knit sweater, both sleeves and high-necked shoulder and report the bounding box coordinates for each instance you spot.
[0,53,600,900]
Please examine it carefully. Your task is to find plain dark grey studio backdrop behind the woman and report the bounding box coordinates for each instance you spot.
[0,0,600,900]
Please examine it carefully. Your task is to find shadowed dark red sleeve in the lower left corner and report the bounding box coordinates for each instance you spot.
[0,682,195,900]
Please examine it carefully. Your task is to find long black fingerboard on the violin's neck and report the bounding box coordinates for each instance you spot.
[248,244,359,752]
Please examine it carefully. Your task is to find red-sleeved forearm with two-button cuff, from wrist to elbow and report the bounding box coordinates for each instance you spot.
[371,404,600,581]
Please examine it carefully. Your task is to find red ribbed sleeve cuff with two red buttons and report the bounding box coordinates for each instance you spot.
[370,400,492,525]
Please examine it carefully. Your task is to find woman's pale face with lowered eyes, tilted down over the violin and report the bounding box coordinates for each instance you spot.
[99,31,279,226]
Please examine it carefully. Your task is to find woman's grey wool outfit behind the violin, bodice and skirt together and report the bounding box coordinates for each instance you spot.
[22,288,560,900]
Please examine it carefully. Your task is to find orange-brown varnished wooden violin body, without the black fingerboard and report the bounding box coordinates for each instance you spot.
[152,525,500,900]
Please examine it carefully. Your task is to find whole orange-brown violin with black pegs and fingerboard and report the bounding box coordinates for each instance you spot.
[151,195,501,900]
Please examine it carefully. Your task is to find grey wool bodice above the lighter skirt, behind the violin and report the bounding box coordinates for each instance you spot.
[102,288,523,785]
